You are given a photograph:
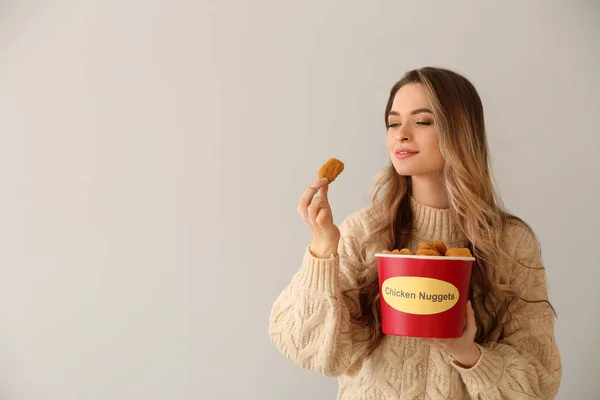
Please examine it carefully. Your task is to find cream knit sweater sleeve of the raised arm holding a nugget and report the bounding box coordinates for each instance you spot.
[269,216,378,376]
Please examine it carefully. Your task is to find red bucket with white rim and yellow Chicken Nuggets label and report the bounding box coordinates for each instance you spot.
[375,253,475,338]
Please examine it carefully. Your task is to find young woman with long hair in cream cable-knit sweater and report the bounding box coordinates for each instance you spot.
[269,68,562,399]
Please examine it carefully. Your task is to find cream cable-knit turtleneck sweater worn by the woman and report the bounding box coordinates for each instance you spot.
[269,200,562,400]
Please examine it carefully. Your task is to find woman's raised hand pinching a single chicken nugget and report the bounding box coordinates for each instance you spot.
[298,178,340,258]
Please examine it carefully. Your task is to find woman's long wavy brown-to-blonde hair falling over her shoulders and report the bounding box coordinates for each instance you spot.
[345,67,552,349]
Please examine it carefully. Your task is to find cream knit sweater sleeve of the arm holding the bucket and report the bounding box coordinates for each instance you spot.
[452,223,562,400]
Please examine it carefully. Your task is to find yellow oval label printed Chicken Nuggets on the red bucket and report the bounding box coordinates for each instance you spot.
[381,276,458,315]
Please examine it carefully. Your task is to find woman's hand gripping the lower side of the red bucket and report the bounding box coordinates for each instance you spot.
[420,301,481,368]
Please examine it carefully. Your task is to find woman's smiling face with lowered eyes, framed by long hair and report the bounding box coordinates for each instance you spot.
[387,84,444,176]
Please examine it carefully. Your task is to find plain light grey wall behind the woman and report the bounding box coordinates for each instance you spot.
[0,0,600,400]
